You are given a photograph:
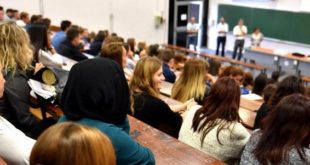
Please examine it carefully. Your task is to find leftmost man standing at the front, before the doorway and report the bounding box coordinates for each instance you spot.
[187,17,199,49]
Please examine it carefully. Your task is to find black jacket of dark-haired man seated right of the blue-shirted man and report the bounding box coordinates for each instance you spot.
[57,40,88,61]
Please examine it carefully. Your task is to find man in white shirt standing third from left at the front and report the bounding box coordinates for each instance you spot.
[232,19,248,60]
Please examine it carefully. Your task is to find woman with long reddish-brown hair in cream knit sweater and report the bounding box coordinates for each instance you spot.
[179,77,250,164]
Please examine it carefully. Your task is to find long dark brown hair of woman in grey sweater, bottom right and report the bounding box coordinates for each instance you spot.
[254,94,310,164]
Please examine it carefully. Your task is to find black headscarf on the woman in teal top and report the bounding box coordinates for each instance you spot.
[61,58,130,125]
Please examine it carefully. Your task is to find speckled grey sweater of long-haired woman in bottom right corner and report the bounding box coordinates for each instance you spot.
[240,129,310,165]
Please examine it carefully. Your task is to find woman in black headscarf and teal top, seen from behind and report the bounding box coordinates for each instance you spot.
[58,58,155,165]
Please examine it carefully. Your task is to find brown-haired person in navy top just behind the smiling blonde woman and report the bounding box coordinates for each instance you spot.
[159,49,177,83]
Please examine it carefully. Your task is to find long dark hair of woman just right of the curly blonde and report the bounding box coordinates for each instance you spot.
[27,23,48,61]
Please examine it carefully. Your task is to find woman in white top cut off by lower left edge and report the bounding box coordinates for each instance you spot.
[0,61,35,165]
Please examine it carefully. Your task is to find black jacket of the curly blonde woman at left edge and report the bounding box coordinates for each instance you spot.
[0,71,54,138]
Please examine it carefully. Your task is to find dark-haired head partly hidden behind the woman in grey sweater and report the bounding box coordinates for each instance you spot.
[267,76,305,111]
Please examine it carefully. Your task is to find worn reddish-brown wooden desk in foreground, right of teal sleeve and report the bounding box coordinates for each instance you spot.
[128,116,225,165]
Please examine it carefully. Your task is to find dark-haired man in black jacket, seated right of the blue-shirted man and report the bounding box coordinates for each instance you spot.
[57,28,88,61]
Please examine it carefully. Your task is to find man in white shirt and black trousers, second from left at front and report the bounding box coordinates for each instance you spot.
[215,17,228,57]
